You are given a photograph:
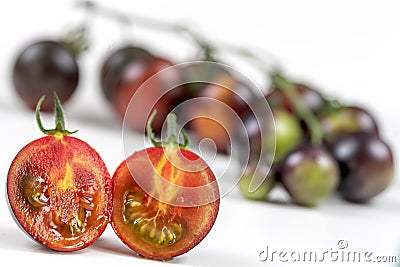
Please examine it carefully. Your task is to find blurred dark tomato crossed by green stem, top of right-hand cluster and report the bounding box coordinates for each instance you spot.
[266,83,324,114]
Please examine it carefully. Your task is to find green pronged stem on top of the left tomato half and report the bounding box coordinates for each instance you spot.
[36,91,78,135]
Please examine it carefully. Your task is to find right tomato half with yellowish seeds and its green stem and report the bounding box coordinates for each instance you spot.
[111,113,219,259]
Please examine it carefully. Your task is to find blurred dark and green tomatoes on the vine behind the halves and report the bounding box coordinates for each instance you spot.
[9,0,394,209]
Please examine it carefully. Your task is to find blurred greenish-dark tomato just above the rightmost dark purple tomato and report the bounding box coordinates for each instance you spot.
[320,106,379,141]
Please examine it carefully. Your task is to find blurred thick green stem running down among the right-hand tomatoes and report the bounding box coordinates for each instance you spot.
[270,72,323,145]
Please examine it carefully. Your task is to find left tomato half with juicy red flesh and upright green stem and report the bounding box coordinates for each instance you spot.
[7,93,112,251]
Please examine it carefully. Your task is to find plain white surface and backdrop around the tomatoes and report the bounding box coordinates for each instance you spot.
[0,0,400,266]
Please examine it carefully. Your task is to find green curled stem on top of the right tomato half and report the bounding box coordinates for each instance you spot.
[146,110,190,149]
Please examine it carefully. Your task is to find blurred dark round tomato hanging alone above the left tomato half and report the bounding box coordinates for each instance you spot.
[13,41,79,111]
